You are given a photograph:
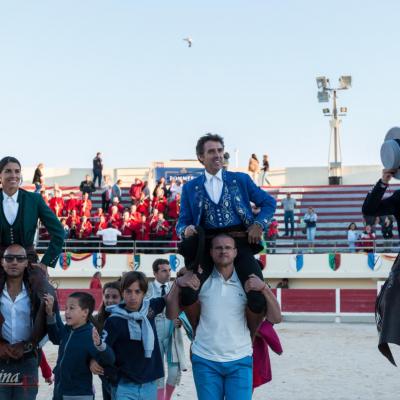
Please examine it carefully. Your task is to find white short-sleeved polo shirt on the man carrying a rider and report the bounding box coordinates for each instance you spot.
[192,267,253,362]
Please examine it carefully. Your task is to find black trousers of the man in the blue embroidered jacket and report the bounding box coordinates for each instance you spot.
[181,238,266,314]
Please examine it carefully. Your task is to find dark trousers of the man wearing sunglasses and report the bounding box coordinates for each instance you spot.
[0,355,39,400]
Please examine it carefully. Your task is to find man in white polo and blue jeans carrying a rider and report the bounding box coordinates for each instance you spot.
[167,234,281,400]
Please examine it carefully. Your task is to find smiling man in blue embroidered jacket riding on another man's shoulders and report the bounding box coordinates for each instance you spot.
[176,134,276,333]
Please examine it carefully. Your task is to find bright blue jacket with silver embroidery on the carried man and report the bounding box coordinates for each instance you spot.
[176,171,276,237]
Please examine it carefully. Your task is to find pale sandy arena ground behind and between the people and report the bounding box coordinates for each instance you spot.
[38,323,400,400]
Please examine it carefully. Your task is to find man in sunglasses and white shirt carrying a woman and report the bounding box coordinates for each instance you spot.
[0,244,48,400]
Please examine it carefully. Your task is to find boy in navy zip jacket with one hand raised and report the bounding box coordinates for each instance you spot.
[45,292,114,400]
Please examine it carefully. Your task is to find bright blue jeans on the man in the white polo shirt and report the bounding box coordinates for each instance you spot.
[192,354,253,400]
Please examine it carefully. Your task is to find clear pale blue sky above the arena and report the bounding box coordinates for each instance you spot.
[0,0,400,167]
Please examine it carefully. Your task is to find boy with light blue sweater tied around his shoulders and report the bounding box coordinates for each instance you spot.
[103,271,165,400]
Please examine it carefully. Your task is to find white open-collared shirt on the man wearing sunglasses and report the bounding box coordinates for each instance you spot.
[0,284,32,344]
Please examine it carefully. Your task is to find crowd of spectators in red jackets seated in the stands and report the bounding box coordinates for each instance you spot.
[36,175,182,241]
